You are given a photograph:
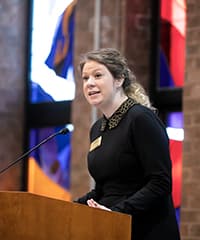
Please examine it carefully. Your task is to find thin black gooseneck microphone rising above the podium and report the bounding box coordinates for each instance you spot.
[0,128,70,174]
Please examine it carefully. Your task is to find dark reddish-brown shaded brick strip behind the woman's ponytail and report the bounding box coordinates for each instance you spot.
[125,0,151,91]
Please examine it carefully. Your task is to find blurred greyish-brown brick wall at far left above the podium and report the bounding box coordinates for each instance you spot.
[0,0,28,190]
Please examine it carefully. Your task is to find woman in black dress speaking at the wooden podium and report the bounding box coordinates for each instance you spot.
[76,48,180,240]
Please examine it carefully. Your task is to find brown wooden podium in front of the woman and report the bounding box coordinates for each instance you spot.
[0,191,131,240]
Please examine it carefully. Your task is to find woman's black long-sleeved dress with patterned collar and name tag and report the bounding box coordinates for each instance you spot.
[77,98,180,240]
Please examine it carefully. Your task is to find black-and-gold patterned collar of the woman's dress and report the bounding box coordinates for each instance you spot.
[100,98,135,132]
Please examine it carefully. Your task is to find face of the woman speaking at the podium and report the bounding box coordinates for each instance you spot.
[82,61,116,108]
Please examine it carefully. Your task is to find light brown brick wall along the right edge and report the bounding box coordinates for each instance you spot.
[181,0,200,240]
